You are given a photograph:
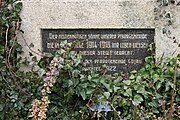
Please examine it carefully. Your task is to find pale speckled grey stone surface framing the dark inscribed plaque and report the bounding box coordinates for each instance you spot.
[19,0,180,57]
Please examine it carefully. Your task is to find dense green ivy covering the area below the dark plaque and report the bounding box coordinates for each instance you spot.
[28,41,180,120]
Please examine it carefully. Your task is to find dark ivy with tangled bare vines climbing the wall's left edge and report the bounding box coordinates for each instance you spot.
[0,0,41,120]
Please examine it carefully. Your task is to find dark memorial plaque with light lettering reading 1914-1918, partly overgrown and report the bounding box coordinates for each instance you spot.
[41,29,155,73]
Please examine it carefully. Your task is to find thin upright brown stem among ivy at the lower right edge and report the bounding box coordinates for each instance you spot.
[167,58,177,120]
